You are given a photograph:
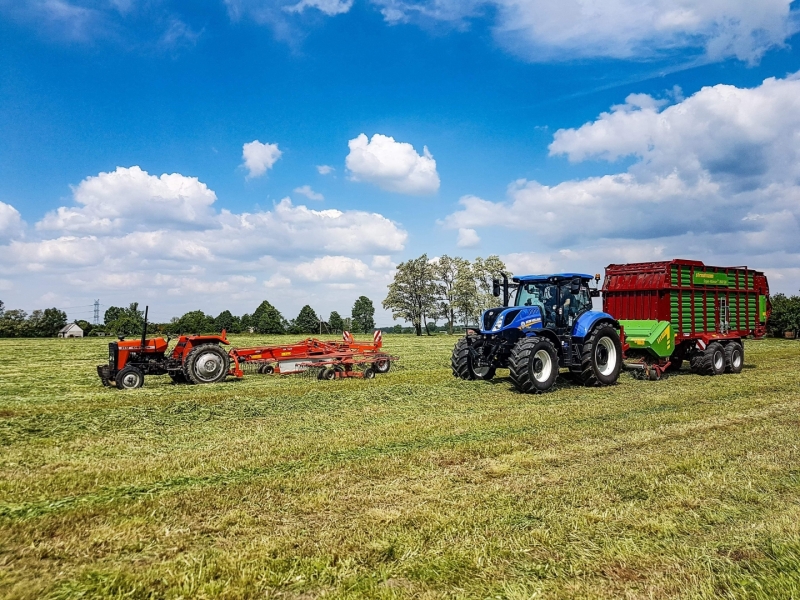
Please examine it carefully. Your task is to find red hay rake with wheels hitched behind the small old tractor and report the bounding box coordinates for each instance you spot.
[229,330,397,377]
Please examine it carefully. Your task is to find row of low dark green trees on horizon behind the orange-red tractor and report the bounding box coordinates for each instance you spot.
[95,296,375,335]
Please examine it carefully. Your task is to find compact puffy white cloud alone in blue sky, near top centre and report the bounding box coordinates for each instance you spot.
[346,133,439,195]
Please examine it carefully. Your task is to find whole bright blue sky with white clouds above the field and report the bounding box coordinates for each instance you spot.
[0,0,800,325]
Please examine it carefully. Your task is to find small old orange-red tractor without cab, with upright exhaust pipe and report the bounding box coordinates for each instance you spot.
[97,308,230,390]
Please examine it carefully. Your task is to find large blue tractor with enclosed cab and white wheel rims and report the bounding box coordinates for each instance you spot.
[451,273,622,394]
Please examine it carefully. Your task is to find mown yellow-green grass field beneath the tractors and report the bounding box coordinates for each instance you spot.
[0,336,800,599]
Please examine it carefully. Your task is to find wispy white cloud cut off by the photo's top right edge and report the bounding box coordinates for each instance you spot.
[373,0,798,62]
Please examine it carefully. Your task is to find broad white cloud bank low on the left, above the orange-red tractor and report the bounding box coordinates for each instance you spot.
[0,167,408,319]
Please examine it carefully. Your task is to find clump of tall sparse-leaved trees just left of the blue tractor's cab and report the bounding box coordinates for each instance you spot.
[383,254,512,335]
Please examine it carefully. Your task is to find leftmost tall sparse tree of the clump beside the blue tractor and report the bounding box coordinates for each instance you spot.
[383,254,436,335]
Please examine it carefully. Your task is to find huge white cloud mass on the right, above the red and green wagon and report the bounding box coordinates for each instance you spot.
[442,76,800,293]
